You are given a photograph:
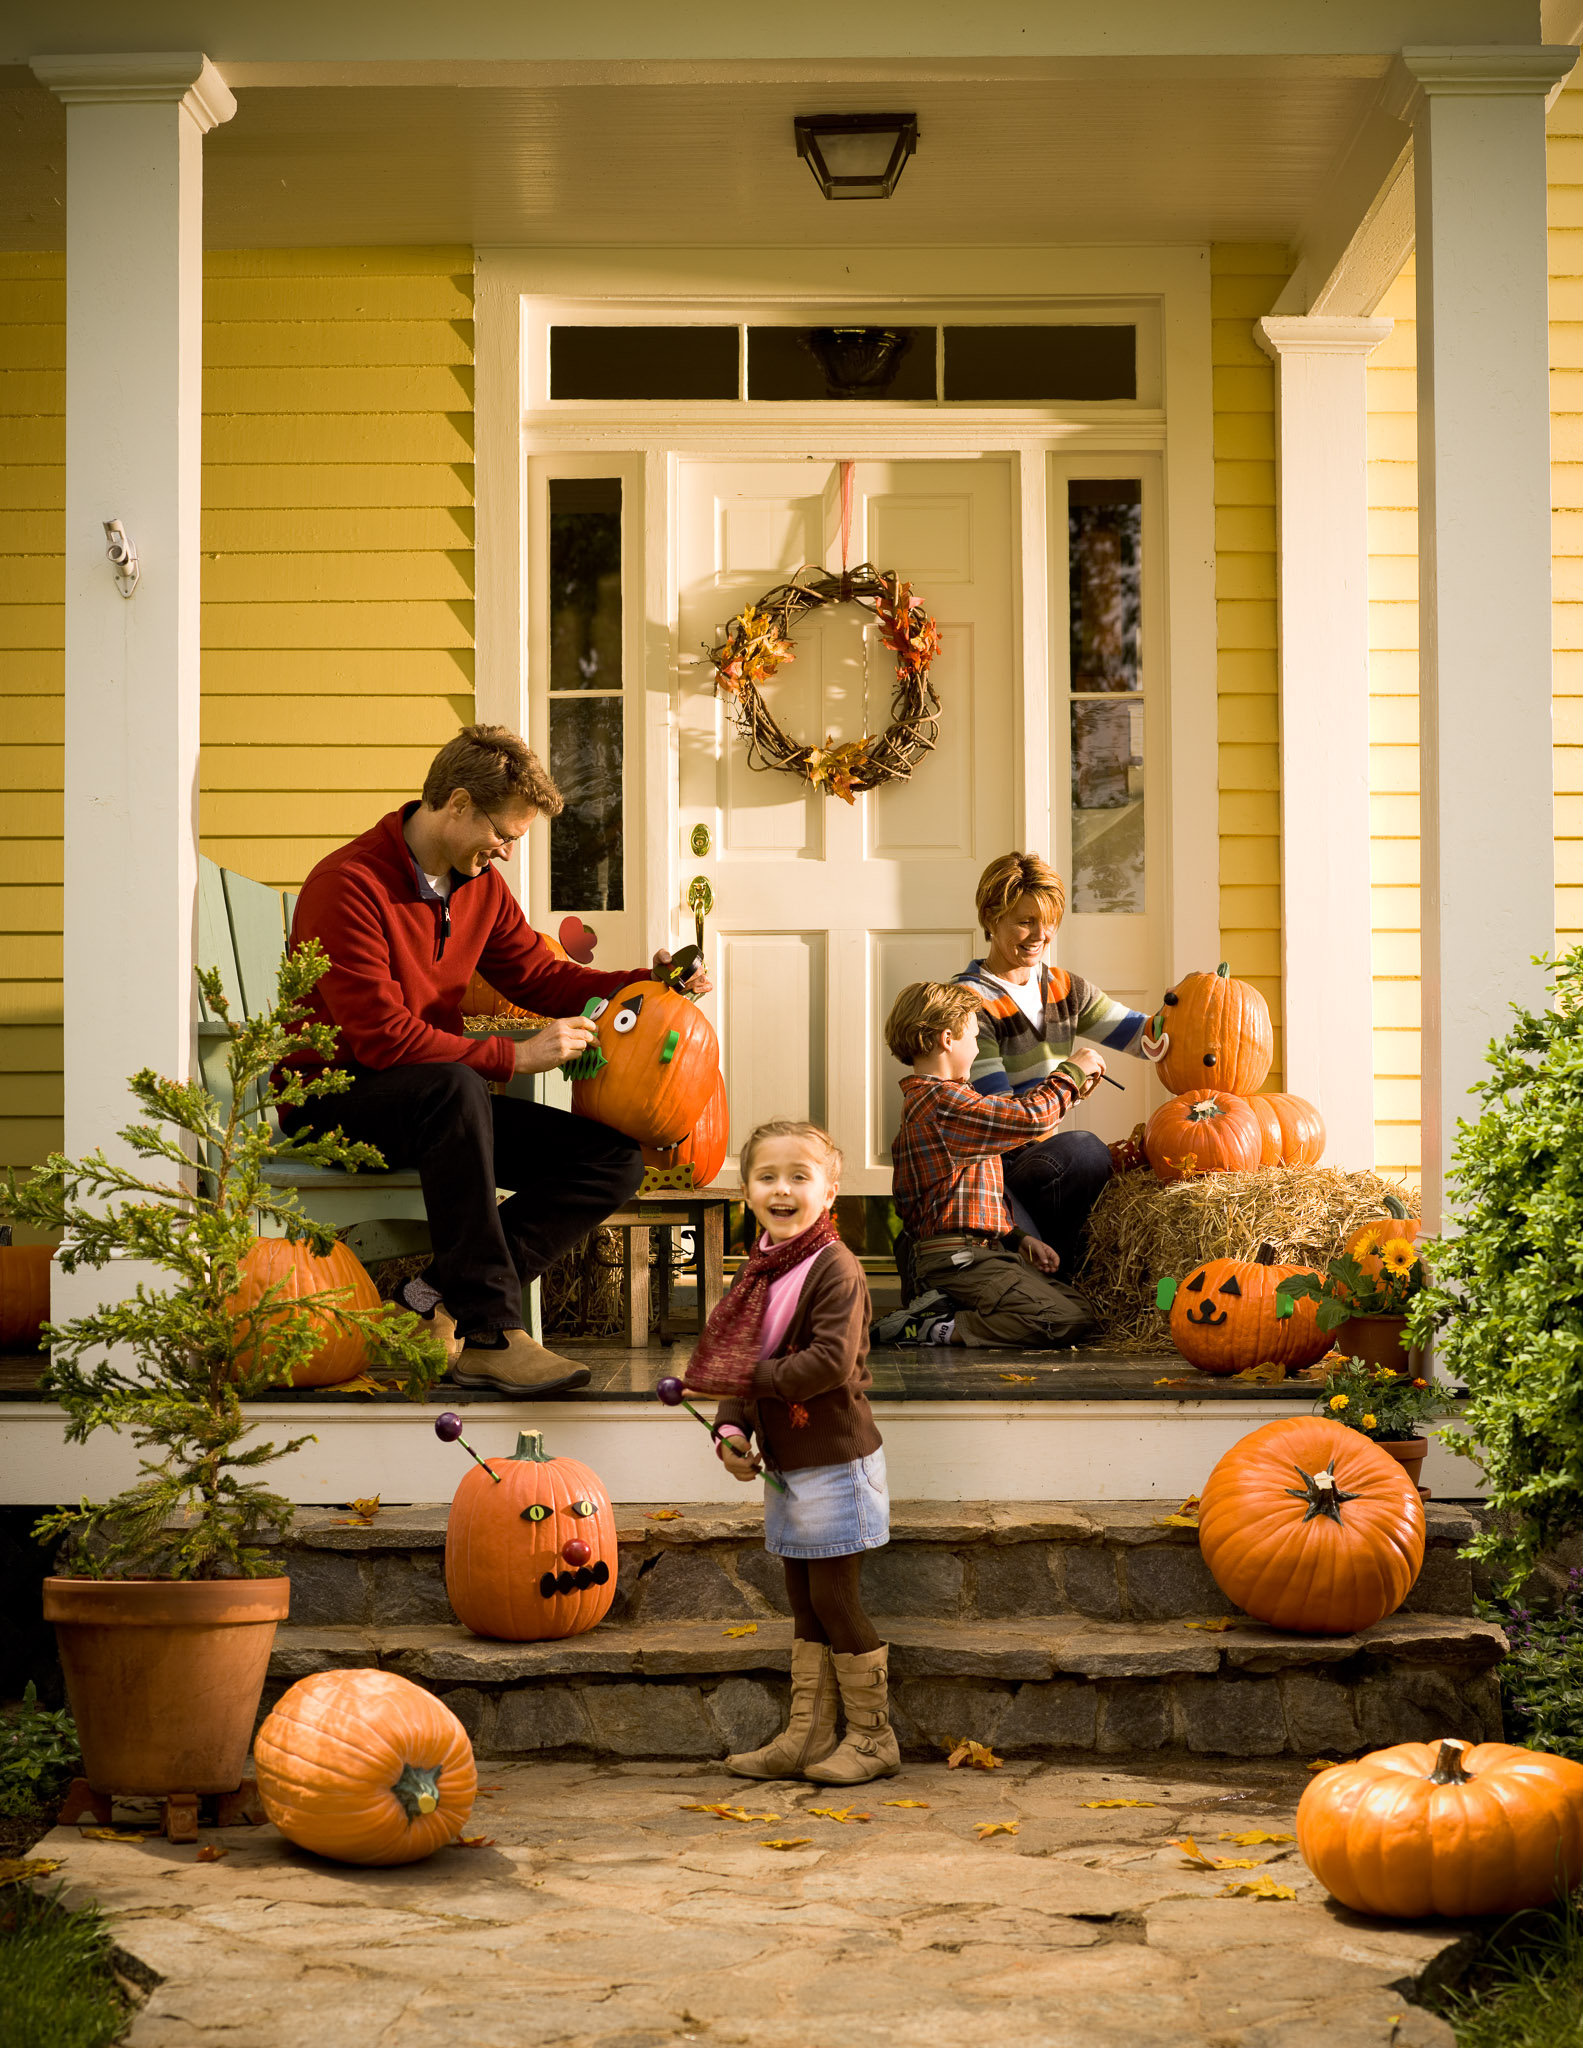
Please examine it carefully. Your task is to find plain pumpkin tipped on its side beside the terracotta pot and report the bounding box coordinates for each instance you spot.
[254,1671,477,1864]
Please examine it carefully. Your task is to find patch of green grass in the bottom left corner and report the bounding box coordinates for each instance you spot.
[0,1884,131,2048]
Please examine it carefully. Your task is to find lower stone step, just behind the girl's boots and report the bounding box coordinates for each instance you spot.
[266,1614,1505,1757]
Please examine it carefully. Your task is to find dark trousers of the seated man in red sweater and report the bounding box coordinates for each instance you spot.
[293,1063,643,1337]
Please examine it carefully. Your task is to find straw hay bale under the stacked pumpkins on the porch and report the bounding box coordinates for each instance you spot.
[1073,1165,1419,1352]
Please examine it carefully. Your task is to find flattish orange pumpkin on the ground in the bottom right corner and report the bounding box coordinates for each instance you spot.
[1296,1739,1583,1919]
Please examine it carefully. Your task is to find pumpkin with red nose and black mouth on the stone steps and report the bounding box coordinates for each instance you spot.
[444,1430,616,1642]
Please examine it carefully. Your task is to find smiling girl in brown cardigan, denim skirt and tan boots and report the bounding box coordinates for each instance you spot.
[686,1118,901,1786]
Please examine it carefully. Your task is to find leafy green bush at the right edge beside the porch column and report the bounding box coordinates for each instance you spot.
[1409,946,1583,1583]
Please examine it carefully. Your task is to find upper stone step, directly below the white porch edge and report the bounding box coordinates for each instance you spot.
[274,1501,1474,1632]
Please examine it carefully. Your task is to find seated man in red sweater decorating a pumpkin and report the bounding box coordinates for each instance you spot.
[283,725,709,1395]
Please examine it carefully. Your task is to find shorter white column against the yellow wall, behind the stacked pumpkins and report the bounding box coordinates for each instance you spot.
[1253,313,1393,1169]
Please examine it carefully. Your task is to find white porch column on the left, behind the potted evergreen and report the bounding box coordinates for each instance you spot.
[33,53,236,1155]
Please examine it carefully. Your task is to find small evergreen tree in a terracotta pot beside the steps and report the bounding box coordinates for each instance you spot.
[0,946,444,1794]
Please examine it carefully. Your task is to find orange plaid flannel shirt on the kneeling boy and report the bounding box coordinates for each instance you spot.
[891,1073,1077,1239]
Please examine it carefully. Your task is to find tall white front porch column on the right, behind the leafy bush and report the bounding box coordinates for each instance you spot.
[1403,45,1577,1223]
